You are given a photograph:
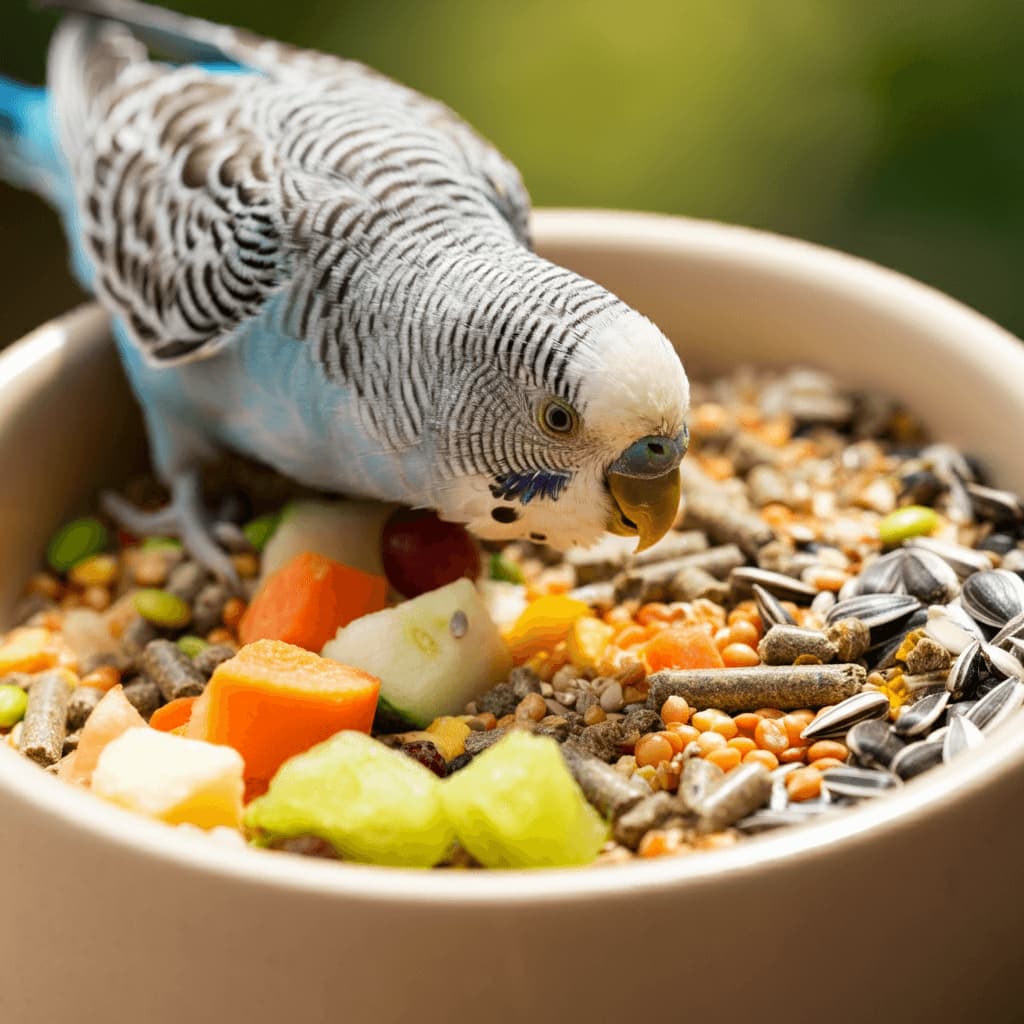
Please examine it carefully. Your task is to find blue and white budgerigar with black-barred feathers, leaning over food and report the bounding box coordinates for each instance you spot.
[0,0,689,574]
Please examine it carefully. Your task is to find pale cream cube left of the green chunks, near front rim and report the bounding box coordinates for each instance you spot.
[92,729,244,828]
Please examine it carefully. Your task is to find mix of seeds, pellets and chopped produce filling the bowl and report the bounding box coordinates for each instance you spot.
[0,370,1024,867]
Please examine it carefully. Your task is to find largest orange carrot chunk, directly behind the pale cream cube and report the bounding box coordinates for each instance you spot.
[186,640,380,784]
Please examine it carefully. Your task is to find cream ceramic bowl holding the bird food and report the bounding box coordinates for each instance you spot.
[0,211,1024,1024]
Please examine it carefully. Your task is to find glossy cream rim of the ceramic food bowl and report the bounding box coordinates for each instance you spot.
[0,209,1024,907]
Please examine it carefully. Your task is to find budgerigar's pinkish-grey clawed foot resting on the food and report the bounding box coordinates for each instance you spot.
[100,473,240,591]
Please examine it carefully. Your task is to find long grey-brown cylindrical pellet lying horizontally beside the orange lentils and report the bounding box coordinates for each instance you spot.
[647,665,867,712]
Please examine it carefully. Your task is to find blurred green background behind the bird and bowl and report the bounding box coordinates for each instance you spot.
[0,0,1024,341]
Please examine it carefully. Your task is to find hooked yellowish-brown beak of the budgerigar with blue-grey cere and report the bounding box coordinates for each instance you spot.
[605,429,689,552]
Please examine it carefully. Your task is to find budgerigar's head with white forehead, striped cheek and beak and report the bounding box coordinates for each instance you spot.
[435,303,689,551]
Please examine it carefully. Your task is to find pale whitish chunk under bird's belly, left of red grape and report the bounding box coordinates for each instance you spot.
[261,501,393,580]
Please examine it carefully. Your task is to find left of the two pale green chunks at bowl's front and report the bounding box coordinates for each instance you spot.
[245,732,455,867]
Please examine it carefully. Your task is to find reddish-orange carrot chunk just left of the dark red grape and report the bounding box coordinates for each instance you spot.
[239,551,387,653]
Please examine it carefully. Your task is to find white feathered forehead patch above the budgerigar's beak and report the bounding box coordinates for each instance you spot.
[580,311,690,438]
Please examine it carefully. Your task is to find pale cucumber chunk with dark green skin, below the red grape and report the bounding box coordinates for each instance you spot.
[324,580,512,729]
